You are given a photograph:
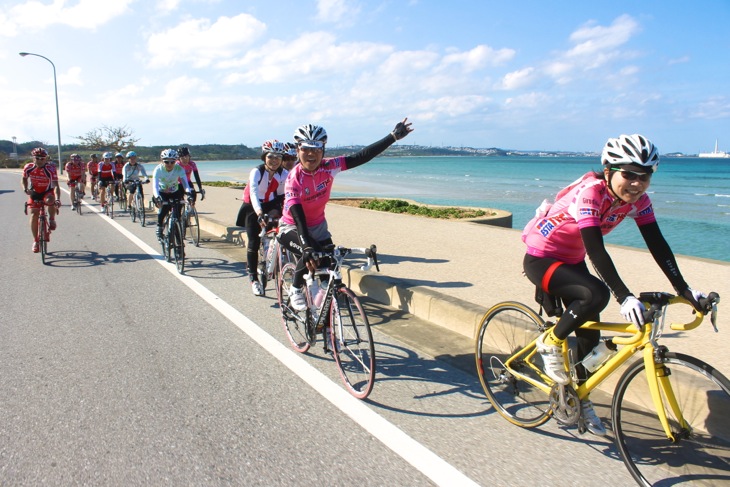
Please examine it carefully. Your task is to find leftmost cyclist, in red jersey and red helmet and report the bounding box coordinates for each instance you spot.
[21,147,61,252]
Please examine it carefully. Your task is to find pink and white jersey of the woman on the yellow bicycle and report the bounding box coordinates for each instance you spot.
[522,173,656,264]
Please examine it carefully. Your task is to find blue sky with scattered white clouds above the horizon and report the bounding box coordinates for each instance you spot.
[0,0,730,153]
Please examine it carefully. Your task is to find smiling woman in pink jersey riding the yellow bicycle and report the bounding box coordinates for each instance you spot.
[522,134,703,435]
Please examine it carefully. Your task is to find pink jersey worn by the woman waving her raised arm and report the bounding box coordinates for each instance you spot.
[281,156,347,227]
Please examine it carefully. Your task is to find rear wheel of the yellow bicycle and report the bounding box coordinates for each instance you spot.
[475,302,550,428]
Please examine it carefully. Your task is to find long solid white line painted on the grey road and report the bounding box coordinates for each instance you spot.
[84,202,479,486]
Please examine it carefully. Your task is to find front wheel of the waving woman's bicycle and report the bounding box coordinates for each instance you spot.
[330,287,375,399]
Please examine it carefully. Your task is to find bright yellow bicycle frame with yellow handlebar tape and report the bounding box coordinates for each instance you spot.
[504,296,704,442]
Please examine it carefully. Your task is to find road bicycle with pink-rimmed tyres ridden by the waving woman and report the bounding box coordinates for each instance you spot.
[277,245,380,399]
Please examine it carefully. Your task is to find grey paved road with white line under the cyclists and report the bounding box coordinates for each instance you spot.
[0,172,632,486]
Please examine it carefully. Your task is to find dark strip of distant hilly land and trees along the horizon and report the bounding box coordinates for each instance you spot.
[0,140,696,167]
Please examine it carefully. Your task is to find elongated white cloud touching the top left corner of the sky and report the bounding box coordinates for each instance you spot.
[0,0,135,36]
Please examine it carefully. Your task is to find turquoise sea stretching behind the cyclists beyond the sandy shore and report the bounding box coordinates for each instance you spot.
[144,156,730,262]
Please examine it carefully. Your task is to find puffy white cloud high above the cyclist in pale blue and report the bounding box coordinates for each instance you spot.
[147,14,266,68]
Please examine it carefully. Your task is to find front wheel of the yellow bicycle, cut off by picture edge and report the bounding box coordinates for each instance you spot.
[612,352,730,486]
